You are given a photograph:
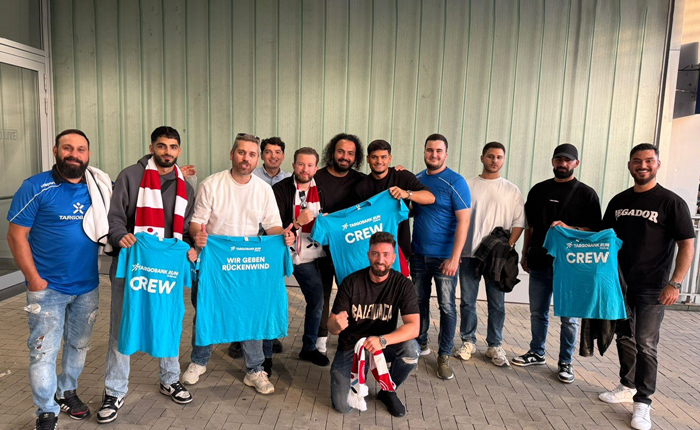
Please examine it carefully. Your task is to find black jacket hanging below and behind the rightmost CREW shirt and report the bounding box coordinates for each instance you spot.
[578,267,632,357]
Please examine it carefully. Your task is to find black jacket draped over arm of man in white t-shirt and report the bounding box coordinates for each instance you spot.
[474,227,520,293]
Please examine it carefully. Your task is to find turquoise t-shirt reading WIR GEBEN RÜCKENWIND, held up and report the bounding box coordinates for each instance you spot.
[195,235,294,346]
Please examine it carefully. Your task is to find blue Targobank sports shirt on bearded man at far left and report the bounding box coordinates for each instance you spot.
[7,166,100,296]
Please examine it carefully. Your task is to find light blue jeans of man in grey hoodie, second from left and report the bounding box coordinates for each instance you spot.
[105,257,180,398]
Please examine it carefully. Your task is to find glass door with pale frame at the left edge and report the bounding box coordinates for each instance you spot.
[0,53,48,290]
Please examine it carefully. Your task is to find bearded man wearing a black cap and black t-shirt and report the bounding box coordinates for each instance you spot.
[512,143,601,384]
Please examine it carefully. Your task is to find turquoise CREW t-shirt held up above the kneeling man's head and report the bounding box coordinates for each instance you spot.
[311,190,408,285]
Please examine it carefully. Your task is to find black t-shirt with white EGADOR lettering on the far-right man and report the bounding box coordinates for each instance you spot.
[603,184,695,291]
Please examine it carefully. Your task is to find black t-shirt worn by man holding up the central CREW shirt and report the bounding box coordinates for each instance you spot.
[355,167,430,258]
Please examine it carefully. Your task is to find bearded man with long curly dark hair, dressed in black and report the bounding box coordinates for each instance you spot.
[314,133,367,354]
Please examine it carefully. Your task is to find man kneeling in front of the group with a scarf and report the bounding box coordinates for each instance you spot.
[328,232,420,417]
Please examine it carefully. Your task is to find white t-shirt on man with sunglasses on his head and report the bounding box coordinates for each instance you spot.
[191,170,282,236]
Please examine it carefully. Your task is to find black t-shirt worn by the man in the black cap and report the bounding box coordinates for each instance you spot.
[525,178,601,247]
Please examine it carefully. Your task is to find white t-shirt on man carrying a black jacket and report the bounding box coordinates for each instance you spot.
[462,176,525,257]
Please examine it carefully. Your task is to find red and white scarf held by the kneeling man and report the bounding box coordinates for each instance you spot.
[348,337,396,411]
